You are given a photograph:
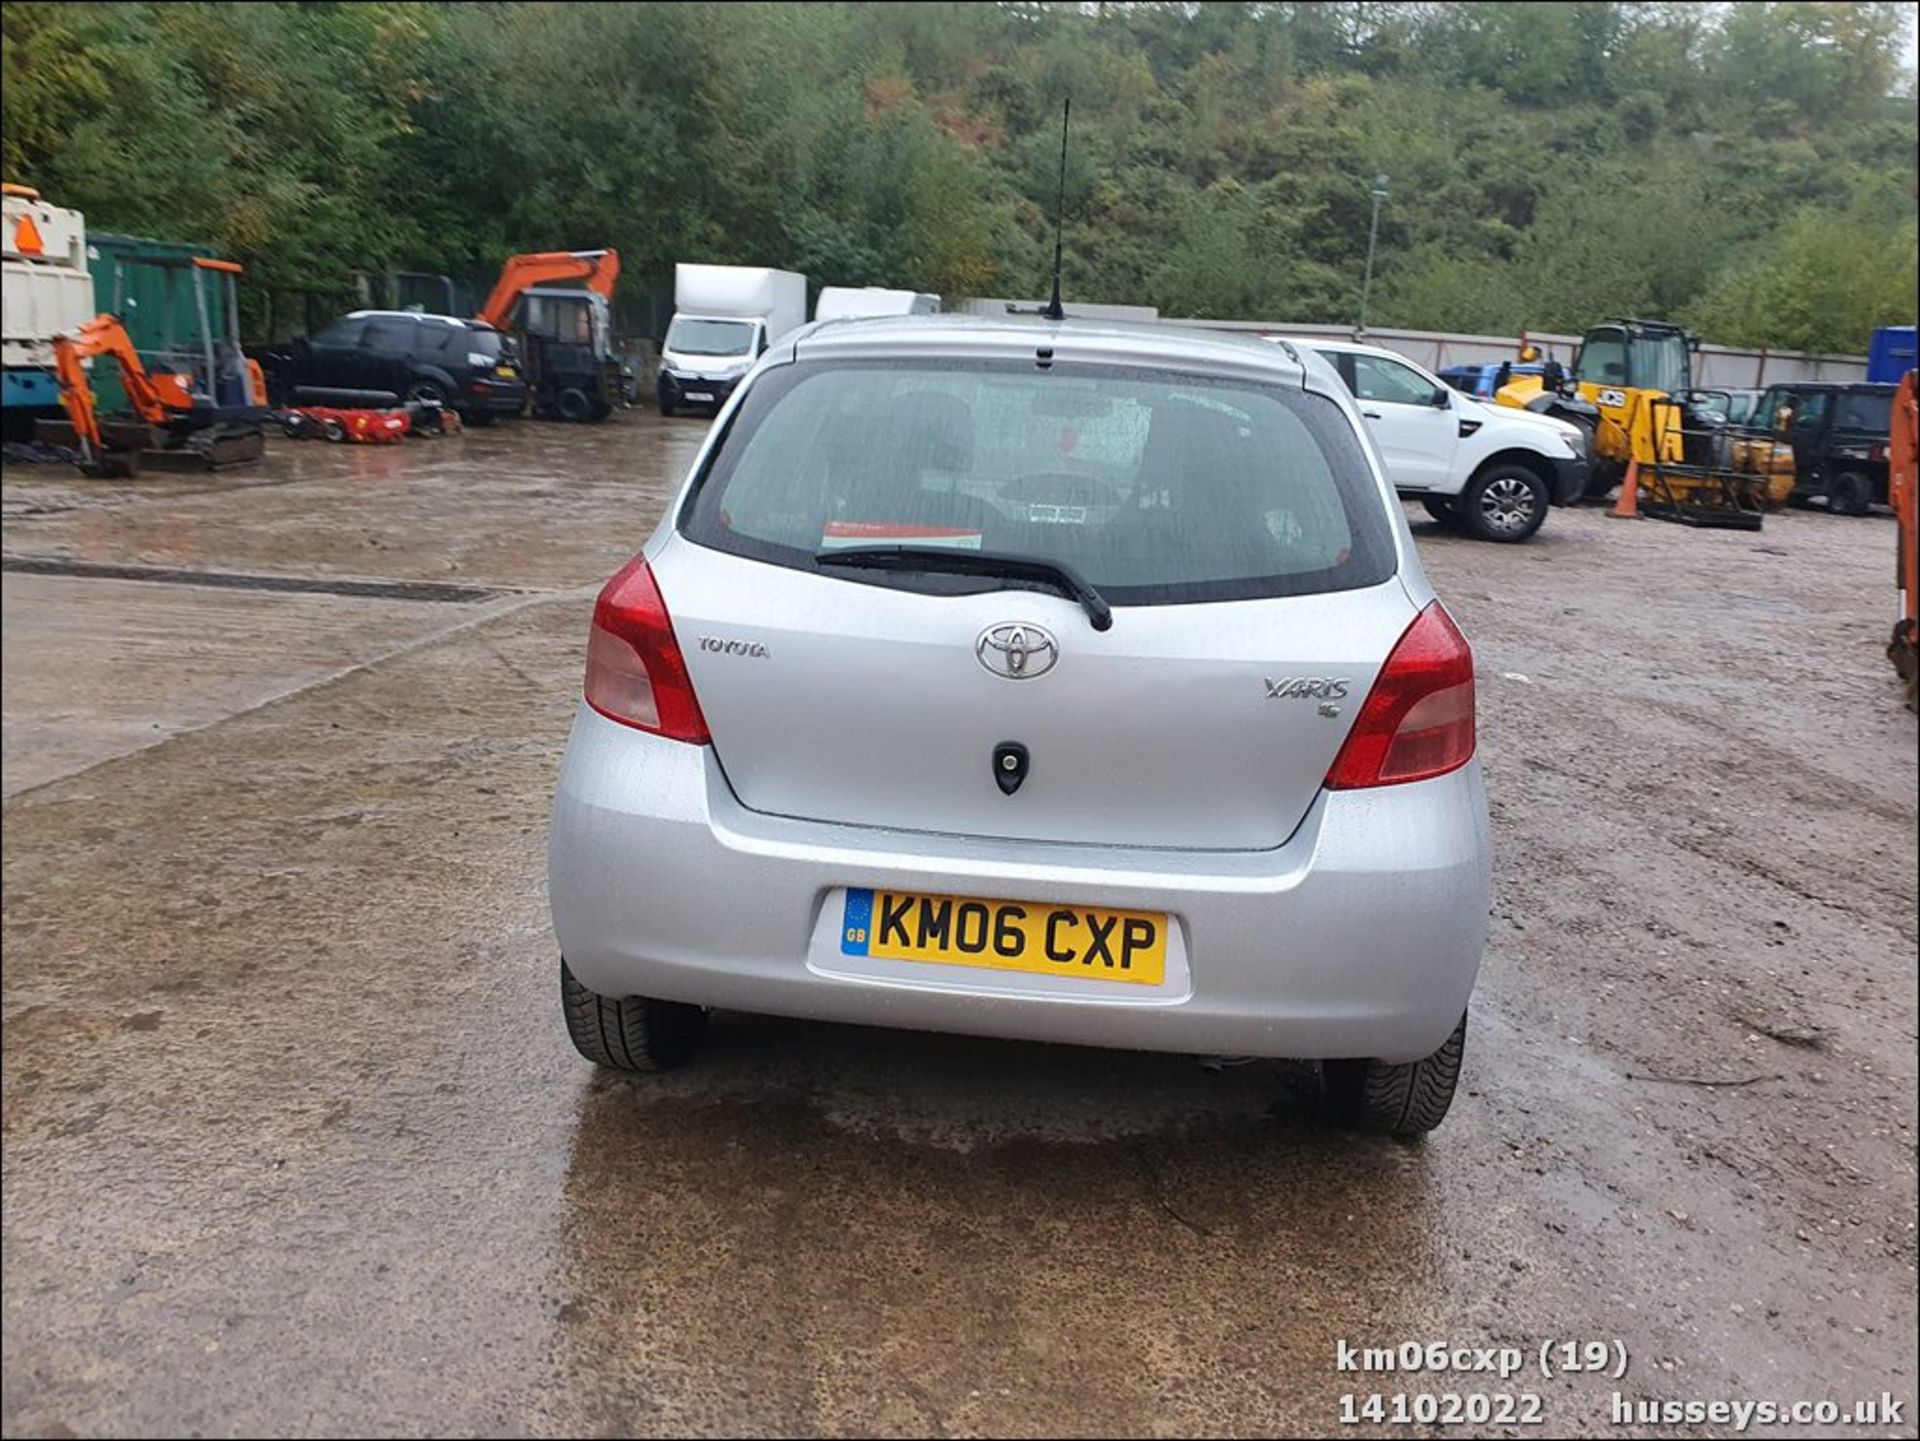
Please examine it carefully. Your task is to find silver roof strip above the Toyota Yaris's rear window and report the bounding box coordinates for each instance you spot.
[793,307,1308,384]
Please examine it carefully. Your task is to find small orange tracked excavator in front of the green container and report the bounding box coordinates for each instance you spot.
[38,255,267,476]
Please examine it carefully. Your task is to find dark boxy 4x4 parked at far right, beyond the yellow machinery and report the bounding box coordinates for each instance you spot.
[1749,382,1893,516]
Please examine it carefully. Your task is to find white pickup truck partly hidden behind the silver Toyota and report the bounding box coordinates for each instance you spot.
[1269,336,1590,541]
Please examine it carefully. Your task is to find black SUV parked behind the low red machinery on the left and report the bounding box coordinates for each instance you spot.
[259,311,526,424]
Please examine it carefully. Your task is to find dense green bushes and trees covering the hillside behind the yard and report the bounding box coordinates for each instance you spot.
[0,0,1920,351]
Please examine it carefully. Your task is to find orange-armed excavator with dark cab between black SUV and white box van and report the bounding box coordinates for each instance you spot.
[478,249,626,420]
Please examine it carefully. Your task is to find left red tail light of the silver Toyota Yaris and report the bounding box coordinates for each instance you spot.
[586,556,708,746]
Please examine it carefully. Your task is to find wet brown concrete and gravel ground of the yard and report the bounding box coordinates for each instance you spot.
[0,414,1916,1435]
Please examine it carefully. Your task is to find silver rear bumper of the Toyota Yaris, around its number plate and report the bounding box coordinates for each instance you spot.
[549,706,1488,1061]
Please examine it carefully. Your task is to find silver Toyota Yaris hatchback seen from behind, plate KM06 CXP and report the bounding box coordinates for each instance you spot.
[551,317,1488,1134]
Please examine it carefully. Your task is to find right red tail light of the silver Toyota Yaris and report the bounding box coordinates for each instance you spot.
[1327,601,1473,791]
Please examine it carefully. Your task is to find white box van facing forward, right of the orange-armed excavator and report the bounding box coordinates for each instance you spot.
[659,263,806,414]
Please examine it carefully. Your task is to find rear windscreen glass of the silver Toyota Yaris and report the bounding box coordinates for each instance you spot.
[682,361,1394,604]
